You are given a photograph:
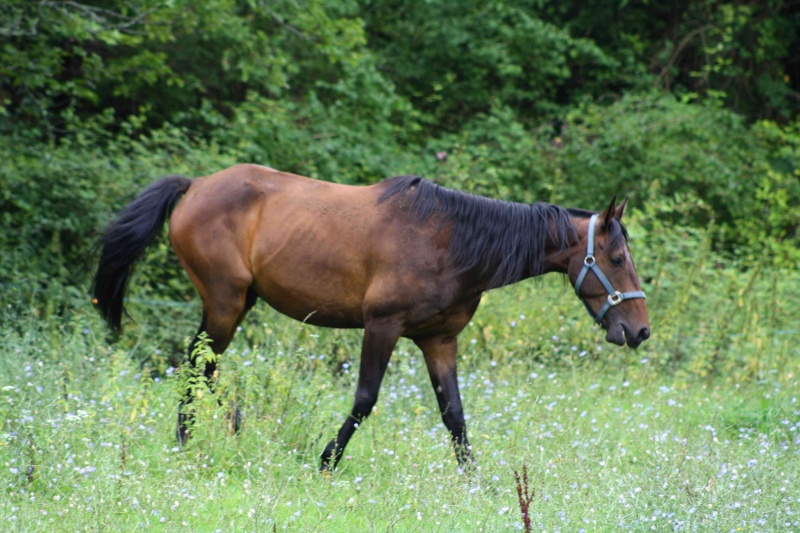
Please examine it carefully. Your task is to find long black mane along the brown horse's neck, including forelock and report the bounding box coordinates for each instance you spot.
[378,176,627,288]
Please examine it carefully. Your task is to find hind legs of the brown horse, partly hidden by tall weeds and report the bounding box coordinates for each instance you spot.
[176,282,256,445]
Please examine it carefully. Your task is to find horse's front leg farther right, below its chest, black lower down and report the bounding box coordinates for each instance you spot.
[414,336,475,467]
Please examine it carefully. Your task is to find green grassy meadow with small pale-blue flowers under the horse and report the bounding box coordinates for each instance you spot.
[0,274,800,532]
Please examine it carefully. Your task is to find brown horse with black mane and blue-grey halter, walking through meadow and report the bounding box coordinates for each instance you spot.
[93,165,650,469]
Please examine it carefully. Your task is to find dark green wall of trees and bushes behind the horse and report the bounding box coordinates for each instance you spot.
[0,0,800,314]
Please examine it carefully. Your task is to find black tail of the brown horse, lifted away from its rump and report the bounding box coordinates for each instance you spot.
[92,176,192,333]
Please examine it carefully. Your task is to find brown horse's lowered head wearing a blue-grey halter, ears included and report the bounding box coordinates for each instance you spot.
[568,197,650,348]
